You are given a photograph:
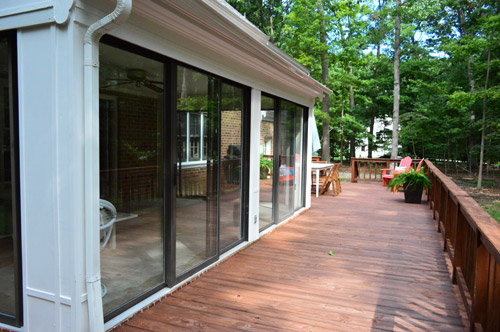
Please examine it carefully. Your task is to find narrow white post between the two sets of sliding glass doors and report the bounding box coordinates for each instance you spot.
[248,89,261,242]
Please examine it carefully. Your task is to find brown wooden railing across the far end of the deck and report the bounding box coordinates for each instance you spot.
[351,158,420,183]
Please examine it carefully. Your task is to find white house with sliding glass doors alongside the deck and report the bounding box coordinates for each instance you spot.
[0,0,330,331]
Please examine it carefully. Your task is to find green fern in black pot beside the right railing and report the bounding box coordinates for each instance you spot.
[387,167,431,204]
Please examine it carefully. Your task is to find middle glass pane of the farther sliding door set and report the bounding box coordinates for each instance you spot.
[278,101,295,221]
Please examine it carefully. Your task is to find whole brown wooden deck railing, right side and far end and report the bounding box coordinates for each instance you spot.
[351,158,500,331]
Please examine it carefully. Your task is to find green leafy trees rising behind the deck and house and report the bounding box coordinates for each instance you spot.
[229,0,500,169]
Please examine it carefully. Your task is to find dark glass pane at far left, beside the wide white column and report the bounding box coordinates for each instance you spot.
[0,35,16,316]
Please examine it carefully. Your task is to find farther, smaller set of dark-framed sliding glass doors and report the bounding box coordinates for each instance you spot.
[259,95,306,231]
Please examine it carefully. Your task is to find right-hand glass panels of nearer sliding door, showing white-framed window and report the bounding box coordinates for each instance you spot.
[175,66,244,280]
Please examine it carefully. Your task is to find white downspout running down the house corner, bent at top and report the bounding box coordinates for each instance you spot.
[83,0,132,332]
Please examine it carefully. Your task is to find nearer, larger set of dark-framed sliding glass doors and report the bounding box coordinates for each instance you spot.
[99,36,248,319]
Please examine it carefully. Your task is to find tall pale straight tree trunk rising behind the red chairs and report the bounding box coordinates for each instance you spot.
[391,0,401,159]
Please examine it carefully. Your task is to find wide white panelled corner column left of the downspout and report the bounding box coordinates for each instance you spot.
[17,23,88,332]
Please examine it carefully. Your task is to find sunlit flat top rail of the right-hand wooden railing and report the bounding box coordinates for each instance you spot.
[425,159,500,264]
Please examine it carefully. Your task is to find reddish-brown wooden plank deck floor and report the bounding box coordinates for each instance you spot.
[111,183,467,332]
